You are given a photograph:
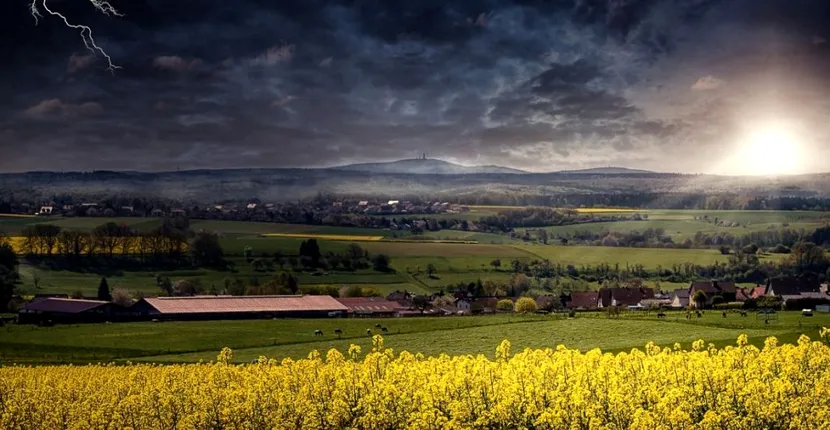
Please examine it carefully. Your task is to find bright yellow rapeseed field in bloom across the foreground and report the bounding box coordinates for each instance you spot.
[0,329,830,430]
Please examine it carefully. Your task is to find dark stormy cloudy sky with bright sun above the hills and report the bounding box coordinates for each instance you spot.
[0,0,830,174]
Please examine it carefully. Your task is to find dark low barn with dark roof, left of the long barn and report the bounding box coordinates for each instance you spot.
[17,297,129,324]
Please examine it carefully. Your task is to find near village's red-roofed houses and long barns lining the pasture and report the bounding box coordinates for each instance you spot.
[17,278,830,324]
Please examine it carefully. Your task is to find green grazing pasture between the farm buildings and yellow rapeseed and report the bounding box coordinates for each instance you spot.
[0,311,830,363]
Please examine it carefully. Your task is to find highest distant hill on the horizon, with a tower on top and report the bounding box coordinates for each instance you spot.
[327,158,527,175]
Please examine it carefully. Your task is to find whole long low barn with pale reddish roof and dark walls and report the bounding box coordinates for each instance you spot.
[133,295,348,320]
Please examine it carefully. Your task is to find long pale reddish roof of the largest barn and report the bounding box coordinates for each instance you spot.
[143,295,348,314]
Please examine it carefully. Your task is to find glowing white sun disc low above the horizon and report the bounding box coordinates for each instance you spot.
[729,125,806,175]
